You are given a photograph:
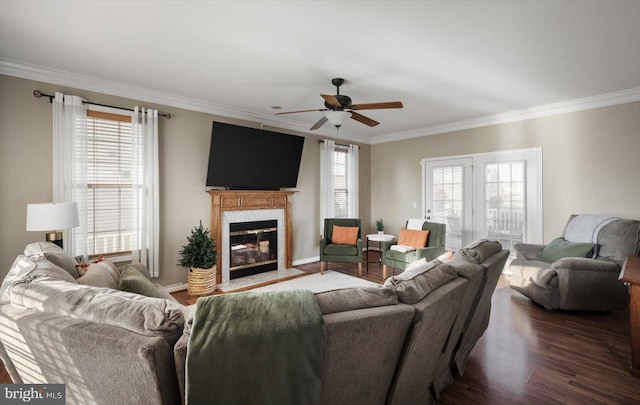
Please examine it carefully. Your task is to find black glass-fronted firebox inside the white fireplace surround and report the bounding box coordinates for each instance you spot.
[229,220,278,280]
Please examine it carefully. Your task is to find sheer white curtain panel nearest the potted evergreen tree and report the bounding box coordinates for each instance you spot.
[131,107,160,277]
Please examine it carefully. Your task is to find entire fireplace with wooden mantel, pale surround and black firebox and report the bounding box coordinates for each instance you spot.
[208,190,294,283]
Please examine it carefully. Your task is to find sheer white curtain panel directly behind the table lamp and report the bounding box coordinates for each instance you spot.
[52,92,87,257]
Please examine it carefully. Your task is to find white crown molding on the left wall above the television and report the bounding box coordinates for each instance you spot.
[0,59,369,144]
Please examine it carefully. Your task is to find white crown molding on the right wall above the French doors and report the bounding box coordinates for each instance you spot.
[371,87,640,145]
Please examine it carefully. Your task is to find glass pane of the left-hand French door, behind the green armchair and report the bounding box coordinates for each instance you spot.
[430,165,464,250]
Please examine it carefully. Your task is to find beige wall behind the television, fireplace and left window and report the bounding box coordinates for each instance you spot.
[0,75,370,285]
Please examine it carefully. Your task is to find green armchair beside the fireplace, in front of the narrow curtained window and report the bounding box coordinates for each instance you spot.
[320,218,362,276]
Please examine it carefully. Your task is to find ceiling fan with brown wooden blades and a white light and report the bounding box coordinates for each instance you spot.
[276,77,402,130]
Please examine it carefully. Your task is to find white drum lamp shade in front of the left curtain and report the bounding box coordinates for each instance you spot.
[27,203,80,231]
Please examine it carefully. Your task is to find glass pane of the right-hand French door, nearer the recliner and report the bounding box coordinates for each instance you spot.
[485,161,526,252]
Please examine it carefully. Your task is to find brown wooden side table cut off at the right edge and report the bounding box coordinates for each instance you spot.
[619,256,640,377]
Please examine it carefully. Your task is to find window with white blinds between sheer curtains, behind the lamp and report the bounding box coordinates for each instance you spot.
[87,110,133,255]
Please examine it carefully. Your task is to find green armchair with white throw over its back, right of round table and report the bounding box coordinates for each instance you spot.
[381,221,447,279]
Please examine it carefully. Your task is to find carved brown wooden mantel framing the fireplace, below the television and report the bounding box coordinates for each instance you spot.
[207,190,295,283]
